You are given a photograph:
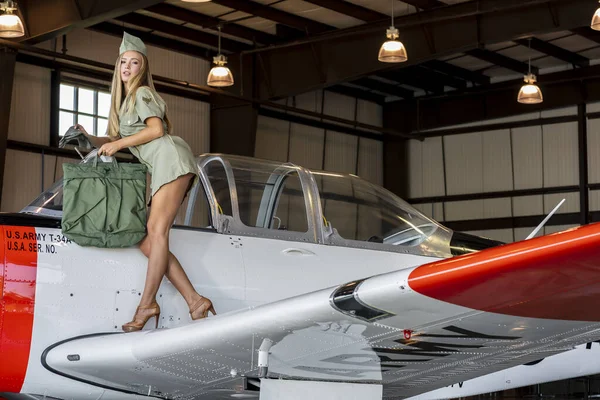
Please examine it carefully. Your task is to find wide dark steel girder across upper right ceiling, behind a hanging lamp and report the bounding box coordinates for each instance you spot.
[246,0,596,99]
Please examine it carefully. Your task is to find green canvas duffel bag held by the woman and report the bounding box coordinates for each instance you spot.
[62,156,146,247]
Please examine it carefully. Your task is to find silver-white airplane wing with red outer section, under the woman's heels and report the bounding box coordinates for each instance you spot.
[42,224,600,398]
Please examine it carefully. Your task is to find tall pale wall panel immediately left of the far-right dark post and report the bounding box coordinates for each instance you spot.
[543,122,579,187]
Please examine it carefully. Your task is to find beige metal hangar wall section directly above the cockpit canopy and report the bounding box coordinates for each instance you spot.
[255,91,383,185]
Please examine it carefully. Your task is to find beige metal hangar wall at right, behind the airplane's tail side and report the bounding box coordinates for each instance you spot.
[409,105,584,242]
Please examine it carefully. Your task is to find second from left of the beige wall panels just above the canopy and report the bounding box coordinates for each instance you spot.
[289,124,325,170]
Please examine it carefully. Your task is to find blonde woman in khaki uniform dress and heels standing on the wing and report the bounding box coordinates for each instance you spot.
[76,32,216,332]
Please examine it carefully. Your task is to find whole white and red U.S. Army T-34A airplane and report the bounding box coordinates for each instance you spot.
[0,150,600,400]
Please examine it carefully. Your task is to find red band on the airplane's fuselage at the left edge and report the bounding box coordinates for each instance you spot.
[0,226,37,393]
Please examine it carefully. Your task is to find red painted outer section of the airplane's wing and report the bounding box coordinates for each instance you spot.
[409,224,600,321]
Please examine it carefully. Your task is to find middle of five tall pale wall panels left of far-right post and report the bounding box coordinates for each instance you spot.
[482,129,513,192]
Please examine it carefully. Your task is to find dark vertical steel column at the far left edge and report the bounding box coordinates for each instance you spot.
[0,48,17,208]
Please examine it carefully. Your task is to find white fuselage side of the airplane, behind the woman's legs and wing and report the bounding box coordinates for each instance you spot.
[5,227,600,400]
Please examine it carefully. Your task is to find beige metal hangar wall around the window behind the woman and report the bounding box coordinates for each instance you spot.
[0,30,210,211]
